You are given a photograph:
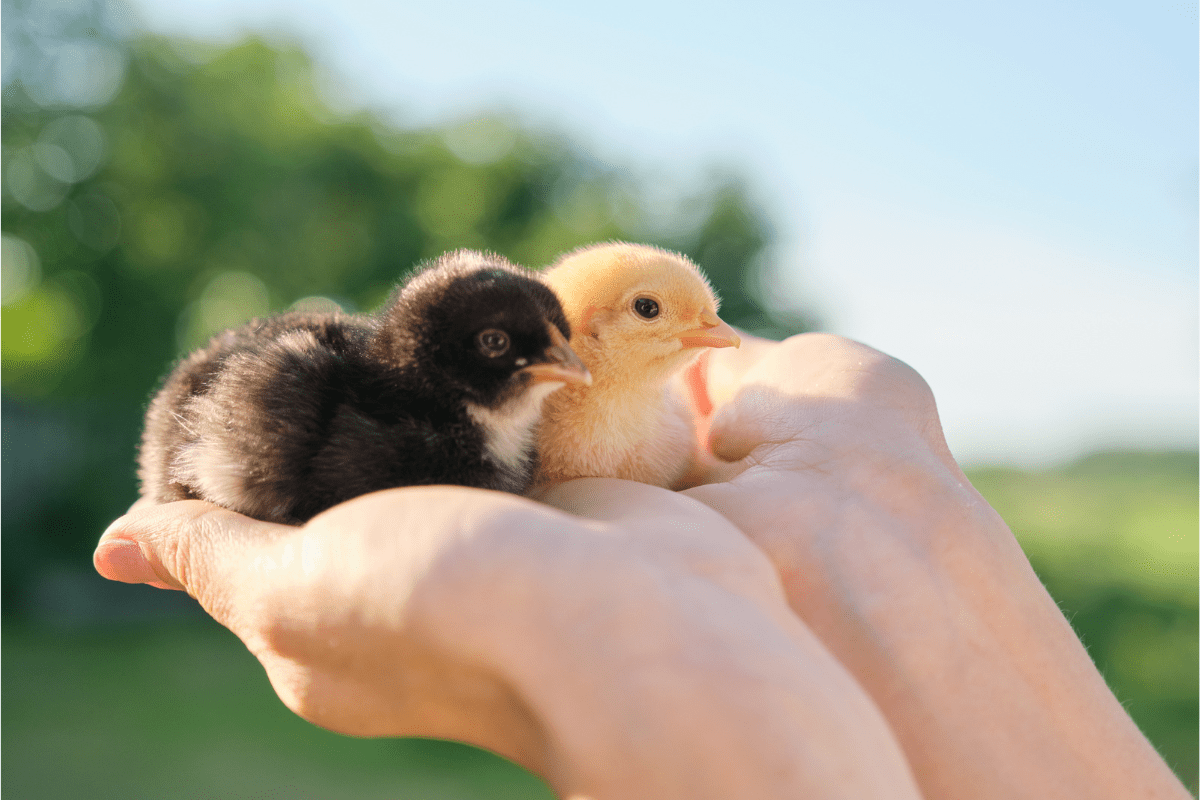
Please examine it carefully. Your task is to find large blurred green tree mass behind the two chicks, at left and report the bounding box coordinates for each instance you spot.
[2,0,800,609]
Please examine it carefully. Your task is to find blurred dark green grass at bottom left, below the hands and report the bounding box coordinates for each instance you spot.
[2,622,553,800]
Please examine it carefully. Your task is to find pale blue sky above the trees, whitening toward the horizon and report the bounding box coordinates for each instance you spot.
[126,0,1200,464]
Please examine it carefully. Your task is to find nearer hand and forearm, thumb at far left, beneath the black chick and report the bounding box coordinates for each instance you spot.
[95,480,917,799]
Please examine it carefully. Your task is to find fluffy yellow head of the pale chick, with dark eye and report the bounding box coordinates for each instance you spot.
[544,242,740,379]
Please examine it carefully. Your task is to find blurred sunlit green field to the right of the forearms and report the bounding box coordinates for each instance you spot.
[968,452,1200,792]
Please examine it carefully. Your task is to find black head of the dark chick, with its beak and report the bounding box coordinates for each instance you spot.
[382,251,592,408]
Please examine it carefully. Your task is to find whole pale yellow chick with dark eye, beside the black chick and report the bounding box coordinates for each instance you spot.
[536,242,740,488]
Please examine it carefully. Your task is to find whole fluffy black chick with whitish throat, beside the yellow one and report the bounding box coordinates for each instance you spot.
[138,251,590,524]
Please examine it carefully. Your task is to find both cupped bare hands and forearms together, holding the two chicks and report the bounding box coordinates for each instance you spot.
[96,335,1188,799]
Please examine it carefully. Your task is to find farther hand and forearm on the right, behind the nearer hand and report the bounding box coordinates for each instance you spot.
[685,335,1188,799]
